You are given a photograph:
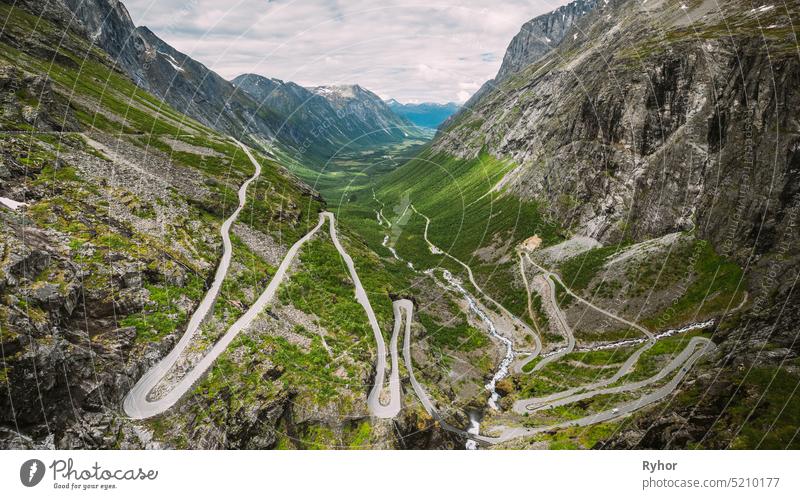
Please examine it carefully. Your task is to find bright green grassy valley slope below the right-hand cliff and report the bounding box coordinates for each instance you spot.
[341,150,560,330]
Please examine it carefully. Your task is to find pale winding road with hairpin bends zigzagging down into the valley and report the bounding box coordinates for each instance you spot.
[123,166,714,445]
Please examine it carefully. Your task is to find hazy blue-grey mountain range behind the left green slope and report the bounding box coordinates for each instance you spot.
[65,0,418,159]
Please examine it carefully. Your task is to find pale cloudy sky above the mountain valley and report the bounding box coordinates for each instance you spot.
[123,0,568,102]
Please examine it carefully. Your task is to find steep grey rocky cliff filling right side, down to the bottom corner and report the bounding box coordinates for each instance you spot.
[422,0,800,447]
